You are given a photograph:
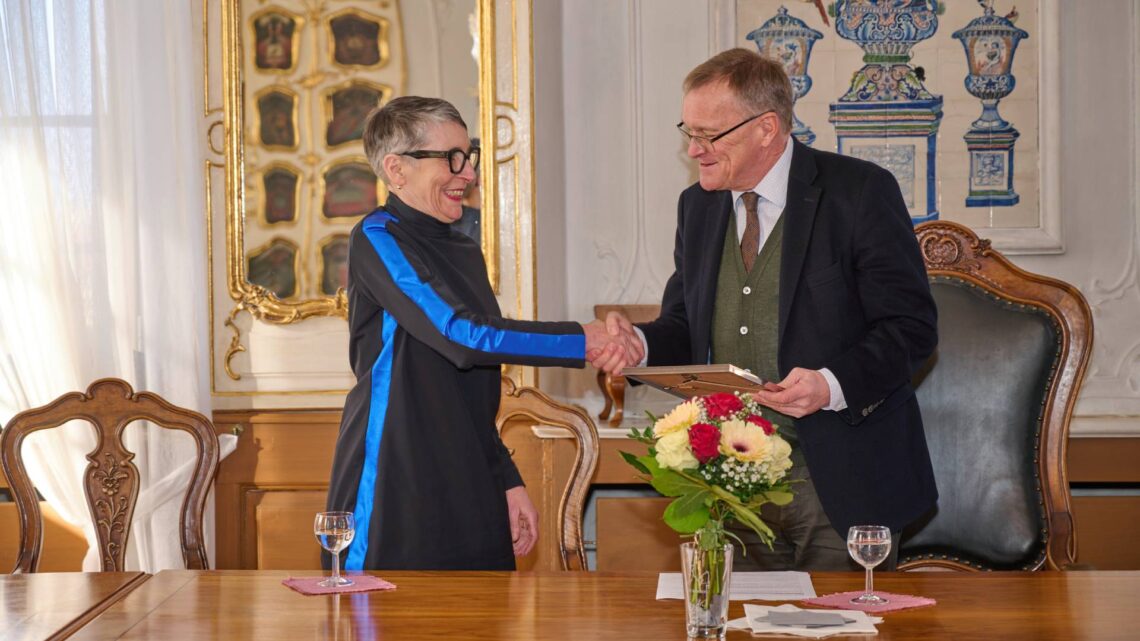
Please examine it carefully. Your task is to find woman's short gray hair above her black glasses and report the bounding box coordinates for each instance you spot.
[364,96,467,185]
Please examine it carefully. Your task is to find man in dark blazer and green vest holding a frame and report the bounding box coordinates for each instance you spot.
[608,49,937,570]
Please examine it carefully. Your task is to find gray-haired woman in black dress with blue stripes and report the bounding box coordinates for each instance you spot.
[328,96,622,570]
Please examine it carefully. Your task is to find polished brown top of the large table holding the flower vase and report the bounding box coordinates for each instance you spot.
[73,570,1140,641]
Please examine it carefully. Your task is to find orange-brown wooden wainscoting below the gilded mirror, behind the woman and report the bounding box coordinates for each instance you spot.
[214,411,575,570]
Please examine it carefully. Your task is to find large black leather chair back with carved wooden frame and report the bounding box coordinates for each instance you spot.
[898,221,1092,570]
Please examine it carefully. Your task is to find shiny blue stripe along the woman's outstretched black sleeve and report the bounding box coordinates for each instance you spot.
[363,212,586,359]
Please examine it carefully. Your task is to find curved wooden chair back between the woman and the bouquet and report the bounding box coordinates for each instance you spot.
[495,376,600,570]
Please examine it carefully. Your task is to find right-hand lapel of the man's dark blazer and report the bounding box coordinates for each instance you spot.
[777,138,822,346]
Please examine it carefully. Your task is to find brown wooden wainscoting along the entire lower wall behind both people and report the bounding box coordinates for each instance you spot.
[215,411,1140,571]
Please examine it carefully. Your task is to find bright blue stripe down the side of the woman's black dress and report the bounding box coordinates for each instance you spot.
[344,311,396,570]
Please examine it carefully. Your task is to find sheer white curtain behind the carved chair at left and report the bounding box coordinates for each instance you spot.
[0,0,233,571]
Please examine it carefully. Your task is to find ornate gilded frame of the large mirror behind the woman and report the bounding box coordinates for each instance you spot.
[220,0,497,321]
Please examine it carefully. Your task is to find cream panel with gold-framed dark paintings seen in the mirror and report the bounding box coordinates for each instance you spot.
[242,0,406,300]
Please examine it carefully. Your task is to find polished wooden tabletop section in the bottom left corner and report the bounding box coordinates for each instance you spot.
[0,573,147,641]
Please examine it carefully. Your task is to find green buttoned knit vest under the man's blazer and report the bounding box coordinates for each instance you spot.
[713,209,796,447]
